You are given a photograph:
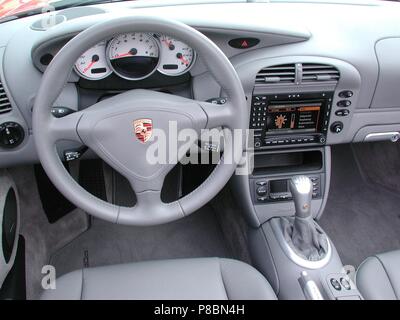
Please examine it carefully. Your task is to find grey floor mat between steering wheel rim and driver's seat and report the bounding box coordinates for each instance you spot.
[50,206,232,276]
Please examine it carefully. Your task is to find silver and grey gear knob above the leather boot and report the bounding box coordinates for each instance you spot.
[289,176,312,218]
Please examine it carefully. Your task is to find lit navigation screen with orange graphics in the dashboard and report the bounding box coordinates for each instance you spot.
[266,102,322,134]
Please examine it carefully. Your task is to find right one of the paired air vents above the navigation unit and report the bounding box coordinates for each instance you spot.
[301,63,340,83]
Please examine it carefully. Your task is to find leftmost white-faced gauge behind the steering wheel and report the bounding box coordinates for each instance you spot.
[75,41,112,80]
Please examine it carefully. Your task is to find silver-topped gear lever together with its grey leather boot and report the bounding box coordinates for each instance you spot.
[281,176,328,261]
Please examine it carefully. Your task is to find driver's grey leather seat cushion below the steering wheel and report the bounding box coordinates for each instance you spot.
[42,258,276,300]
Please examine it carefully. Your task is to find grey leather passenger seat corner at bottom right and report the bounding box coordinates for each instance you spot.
[356,250,400,300]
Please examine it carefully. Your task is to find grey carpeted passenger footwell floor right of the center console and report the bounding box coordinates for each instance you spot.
[320,145,400,266]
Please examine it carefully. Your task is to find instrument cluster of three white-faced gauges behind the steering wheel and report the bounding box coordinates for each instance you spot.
[75,32,196,80]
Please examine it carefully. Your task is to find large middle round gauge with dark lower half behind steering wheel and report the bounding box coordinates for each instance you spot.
[108,32,159,80]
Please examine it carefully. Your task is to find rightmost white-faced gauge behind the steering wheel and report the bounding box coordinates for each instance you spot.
[158,35,196,76]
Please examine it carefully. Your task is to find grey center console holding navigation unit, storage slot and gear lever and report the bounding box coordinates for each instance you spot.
[232,66,362,299]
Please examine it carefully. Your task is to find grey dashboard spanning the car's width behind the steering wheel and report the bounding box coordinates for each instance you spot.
[0,1,400,167]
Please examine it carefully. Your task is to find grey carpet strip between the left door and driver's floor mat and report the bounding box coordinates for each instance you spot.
[9,166,88,300]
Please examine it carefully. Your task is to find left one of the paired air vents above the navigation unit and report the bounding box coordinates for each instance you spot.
[256,64,296,85]
